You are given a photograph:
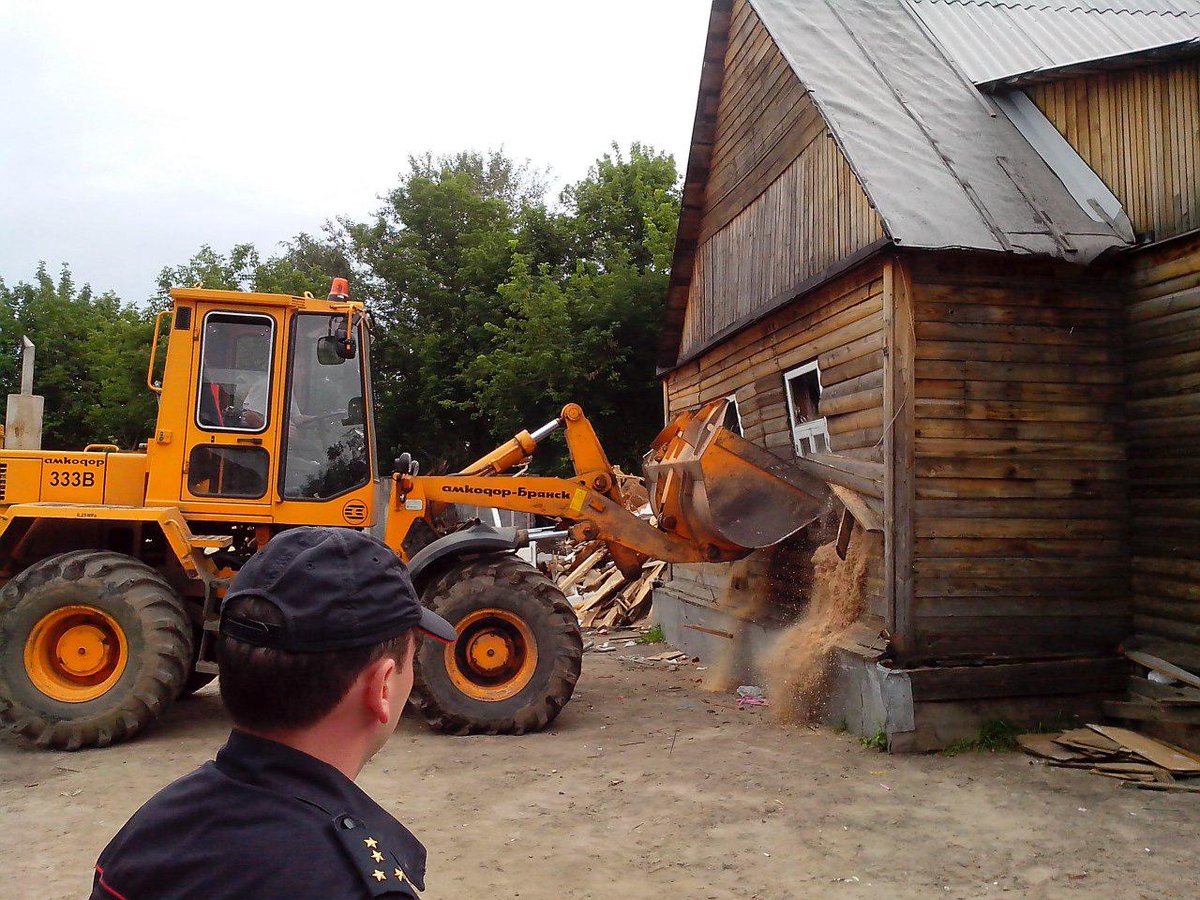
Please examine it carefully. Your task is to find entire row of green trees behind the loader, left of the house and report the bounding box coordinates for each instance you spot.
[0,144,679,470]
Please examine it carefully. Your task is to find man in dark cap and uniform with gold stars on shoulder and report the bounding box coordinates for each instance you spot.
[91,528,455,900]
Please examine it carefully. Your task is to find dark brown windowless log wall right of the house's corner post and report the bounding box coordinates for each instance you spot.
[896,254,1129,660]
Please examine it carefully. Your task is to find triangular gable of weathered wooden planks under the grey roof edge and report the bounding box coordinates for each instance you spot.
[680,0,883,358]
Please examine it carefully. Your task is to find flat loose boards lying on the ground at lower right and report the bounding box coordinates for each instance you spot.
[1016,725,1200,793]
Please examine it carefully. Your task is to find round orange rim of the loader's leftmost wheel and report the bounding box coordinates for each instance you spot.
[25,606,130,703]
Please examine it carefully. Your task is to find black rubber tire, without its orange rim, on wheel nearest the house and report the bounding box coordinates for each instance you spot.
[412,554,583,734]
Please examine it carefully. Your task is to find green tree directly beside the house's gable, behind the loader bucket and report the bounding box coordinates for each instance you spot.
[470,144,680,472]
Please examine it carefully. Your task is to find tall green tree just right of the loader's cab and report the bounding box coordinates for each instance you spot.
[343,152,544,468]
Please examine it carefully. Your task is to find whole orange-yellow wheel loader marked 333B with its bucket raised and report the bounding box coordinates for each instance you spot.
[0,278,824,750]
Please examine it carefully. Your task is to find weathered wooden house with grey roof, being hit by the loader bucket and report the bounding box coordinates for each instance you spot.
[655,0,1200,749]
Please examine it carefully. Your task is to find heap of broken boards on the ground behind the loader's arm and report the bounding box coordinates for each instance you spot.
[556,541,666,628]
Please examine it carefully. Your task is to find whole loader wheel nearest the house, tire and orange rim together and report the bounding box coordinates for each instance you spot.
[413,554,583,734]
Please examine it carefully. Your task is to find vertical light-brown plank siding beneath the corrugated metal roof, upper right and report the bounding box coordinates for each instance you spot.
[1027,59,1200,240]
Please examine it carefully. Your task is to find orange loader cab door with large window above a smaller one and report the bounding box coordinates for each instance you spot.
[180,306,283,518]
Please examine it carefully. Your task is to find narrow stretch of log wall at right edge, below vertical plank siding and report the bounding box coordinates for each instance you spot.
[1126,234,1200,672]
